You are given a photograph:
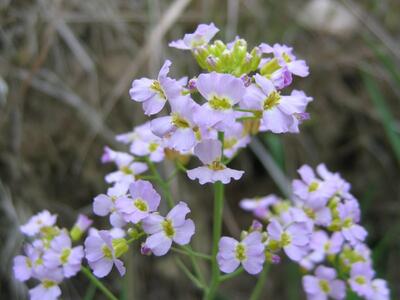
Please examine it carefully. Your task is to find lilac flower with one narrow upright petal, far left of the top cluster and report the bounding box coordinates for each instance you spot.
[129,60,181,115]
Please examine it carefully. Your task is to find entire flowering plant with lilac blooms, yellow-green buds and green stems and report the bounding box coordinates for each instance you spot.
[14,23,389,300]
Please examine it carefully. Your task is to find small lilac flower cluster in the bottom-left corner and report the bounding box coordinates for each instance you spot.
[13,210,92,300]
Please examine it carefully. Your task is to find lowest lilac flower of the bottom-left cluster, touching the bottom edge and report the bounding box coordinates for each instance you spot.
[29,270,63,300]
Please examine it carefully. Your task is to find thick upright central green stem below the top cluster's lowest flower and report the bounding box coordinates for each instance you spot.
[206,181,224,300]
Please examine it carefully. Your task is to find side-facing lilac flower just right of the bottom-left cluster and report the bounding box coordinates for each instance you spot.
[85,230,125,278]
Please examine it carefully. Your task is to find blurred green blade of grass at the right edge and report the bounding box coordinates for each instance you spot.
[362,72,400,165]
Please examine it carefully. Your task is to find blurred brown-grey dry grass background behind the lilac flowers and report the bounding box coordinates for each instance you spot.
[0,0,400,300]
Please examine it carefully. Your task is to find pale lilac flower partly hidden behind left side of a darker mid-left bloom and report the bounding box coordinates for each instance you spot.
[93,185,127,227]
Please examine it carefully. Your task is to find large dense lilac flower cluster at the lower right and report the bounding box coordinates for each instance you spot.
[233,164,389,300]
